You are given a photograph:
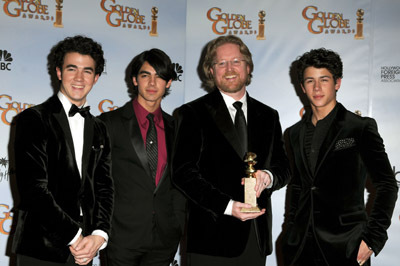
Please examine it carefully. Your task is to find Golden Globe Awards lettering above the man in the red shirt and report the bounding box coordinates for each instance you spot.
[100,0,150,30]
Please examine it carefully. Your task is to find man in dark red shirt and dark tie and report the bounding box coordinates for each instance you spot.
[100,49,186,266]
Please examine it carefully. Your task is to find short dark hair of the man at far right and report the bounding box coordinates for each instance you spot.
[297,48,343,84]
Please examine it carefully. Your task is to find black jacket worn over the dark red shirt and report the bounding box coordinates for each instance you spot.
[100,101,186,249]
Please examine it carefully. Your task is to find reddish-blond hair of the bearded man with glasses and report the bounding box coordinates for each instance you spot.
[203,35,254,88]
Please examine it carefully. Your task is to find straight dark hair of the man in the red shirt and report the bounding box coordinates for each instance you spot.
[128,48,177,98]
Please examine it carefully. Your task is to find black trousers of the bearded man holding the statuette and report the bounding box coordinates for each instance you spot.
[187,223,267,266]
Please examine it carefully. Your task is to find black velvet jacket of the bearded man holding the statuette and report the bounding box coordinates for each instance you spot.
[173,90,289,257]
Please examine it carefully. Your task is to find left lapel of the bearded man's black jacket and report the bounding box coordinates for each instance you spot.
[206,89,244,159]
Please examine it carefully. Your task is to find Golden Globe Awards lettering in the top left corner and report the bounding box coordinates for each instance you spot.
[3,0,57,24]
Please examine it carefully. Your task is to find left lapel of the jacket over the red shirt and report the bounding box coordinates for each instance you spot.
[122,101,152,181]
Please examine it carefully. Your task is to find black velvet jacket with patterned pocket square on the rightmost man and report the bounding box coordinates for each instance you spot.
[283,103,398,265]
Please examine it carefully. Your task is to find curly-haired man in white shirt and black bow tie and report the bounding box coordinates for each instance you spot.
[12,36,114,266]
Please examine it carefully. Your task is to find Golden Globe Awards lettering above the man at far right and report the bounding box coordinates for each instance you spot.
[302,6,355,36]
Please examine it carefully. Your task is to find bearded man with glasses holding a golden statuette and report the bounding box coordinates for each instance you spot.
[173,36,289,266]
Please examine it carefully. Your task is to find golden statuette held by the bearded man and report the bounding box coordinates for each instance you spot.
[240,152,260,212]
